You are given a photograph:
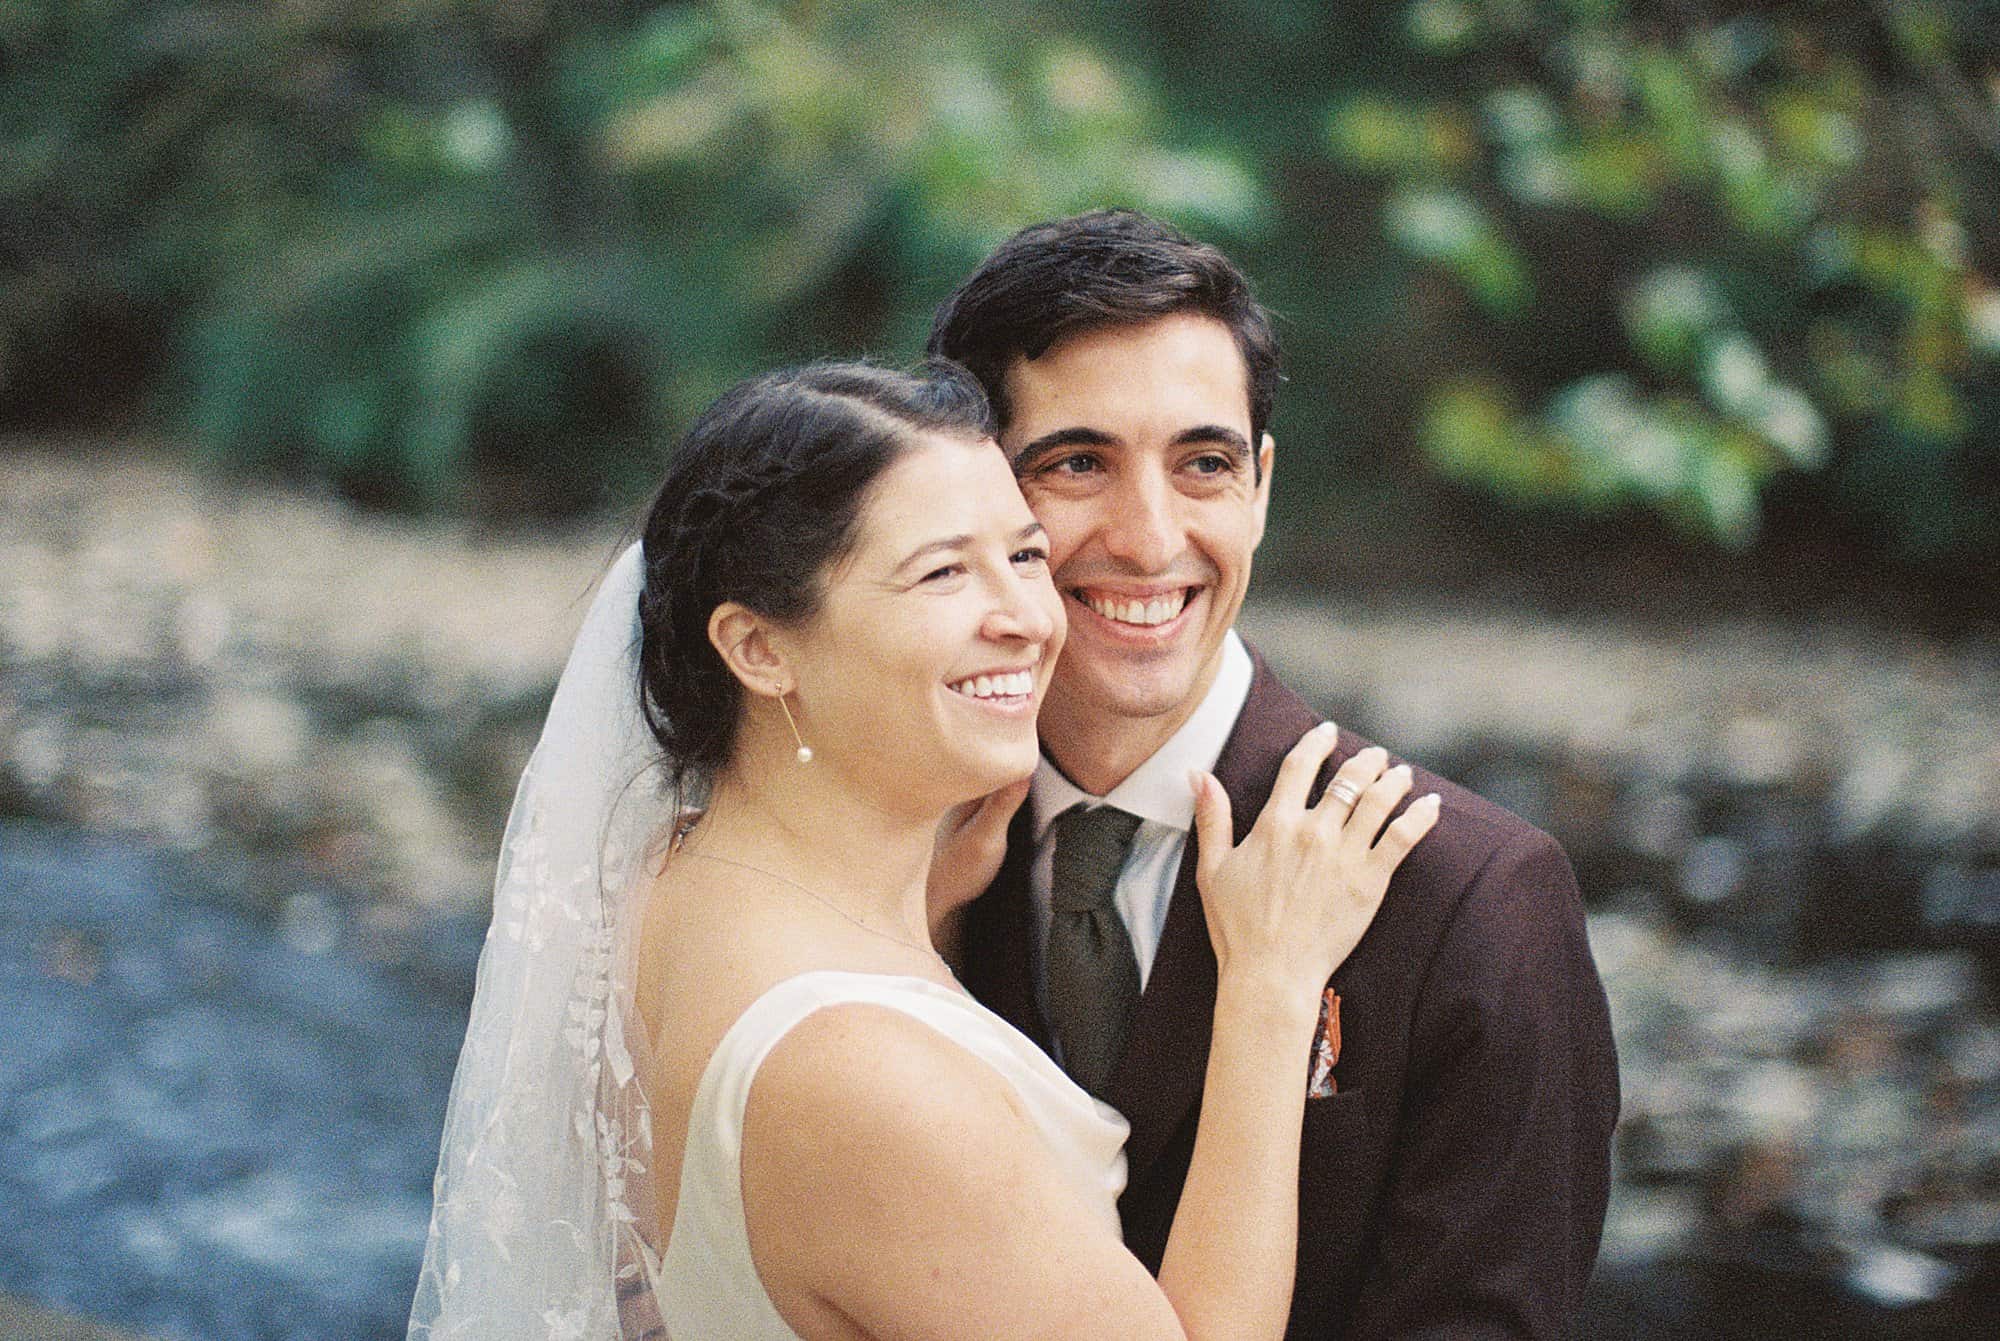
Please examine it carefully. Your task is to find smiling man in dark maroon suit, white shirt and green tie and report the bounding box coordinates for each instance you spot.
[930,210,1618,1341]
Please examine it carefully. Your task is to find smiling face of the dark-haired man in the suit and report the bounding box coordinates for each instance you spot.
[1000,314,1272,763]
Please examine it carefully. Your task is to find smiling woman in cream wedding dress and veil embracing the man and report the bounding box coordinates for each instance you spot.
[410,364,1436,1341]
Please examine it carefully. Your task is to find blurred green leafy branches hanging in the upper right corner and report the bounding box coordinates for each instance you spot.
[1328,0,2000,558]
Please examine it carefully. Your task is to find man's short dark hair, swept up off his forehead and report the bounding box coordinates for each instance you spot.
[928,210,1280,454]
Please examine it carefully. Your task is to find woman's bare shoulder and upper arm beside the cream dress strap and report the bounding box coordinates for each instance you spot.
[742,1003,1178,1339]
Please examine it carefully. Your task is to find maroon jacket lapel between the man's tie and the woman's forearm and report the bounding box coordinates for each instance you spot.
[1110,650,1320,1185]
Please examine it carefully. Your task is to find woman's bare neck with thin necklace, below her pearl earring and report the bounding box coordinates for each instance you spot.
[688,743,938,945]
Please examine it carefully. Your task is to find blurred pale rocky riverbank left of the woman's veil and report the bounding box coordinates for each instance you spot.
[0,440,616,924]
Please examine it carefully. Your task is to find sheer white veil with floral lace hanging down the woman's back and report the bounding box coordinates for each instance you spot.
[410,544,668,1341]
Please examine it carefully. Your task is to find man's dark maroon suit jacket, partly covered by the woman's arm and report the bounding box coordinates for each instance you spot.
[964,656,1618,1341]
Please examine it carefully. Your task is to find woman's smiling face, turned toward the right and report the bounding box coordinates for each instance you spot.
[784,434,1064,809]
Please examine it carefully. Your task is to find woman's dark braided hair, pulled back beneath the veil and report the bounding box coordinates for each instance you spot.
[638,360,994,789]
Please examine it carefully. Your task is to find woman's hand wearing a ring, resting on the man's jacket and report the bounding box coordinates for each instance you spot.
[1190,723,1438,1003]
